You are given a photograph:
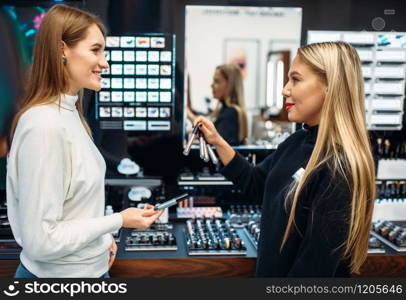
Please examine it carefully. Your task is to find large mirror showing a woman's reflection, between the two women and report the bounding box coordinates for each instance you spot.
[184,5,302,148]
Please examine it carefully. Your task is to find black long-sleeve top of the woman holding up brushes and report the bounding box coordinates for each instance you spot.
[222,126,351,277]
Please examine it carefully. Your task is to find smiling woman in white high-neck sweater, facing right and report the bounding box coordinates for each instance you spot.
[7,5,161,278]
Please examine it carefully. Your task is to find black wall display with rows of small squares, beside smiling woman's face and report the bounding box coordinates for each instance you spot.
[96,33,175,132]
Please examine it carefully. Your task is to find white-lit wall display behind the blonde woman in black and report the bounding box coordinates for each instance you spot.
[307,31,406,130]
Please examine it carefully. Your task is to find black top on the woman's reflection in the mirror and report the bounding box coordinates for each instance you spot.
[214,104,241,146]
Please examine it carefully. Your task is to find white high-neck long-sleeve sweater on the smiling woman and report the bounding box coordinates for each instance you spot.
[7,95,123,277]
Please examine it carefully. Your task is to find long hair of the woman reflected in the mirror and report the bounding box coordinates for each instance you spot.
[211,64,248,142]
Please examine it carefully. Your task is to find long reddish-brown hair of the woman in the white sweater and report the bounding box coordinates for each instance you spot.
[10,4,106,140]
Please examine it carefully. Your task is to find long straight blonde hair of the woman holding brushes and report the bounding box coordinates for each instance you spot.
[281,42,375,273]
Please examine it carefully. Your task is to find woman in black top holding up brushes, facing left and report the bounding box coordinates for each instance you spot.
[194,42,375,277]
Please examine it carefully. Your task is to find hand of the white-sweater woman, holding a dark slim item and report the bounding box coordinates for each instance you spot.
[120,204,163,229]
